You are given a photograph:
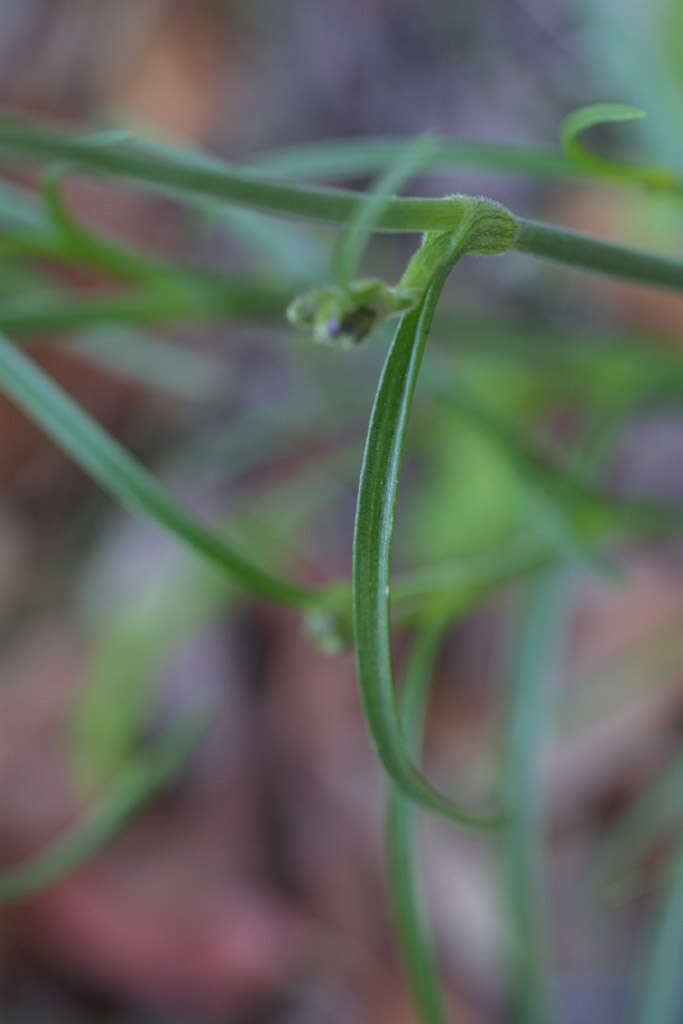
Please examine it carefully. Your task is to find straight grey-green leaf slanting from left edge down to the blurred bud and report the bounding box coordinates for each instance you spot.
[0,335,316,607]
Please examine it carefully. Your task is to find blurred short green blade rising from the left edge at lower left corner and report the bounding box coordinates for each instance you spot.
[0,718,207,904]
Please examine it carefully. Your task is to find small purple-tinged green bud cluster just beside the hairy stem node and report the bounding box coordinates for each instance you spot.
[287,279,419,348]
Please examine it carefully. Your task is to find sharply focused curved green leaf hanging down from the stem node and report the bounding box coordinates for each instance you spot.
[353,260,500,827]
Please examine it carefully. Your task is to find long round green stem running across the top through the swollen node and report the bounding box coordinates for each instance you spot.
[0,121,683,291]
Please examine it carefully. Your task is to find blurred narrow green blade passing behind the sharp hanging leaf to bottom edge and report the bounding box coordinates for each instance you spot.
[386,621,447,1024]
